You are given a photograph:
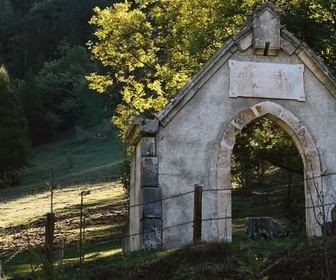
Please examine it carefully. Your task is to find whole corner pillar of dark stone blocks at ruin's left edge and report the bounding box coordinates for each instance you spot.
[123,119,162,253]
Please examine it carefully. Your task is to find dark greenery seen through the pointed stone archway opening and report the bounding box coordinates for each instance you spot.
[231,118,305,238]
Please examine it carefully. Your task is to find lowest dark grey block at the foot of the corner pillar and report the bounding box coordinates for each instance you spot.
[142,218,162,250]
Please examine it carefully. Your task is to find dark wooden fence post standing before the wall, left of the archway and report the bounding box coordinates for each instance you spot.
[193,184,203,244]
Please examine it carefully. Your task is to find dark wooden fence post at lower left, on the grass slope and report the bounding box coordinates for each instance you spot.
[44,213,55,280]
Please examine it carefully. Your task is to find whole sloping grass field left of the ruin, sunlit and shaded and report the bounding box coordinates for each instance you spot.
[0,124,127,279]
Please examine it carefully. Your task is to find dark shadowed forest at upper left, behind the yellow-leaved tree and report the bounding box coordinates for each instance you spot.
[0,0,118,145]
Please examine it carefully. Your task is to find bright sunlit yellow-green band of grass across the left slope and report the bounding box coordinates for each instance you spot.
[0,182,126,256]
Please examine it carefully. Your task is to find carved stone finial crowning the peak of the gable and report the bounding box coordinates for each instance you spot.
[252,2,282,55]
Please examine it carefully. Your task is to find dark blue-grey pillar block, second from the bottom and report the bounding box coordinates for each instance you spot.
[142,187,162,218]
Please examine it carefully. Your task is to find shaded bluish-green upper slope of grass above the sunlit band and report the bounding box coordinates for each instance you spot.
[0,122,125,202]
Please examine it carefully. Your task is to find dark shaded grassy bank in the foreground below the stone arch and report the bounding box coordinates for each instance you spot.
[88,238,336,280]
